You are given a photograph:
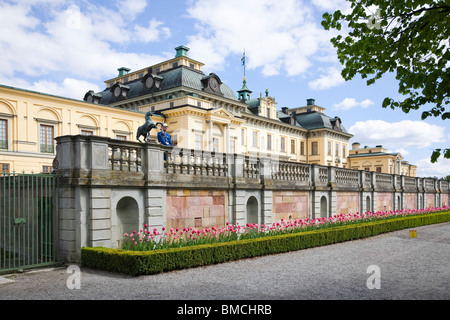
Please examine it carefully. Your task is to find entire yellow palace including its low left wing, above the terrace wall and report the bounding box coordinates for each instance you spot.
[0,46,418,173]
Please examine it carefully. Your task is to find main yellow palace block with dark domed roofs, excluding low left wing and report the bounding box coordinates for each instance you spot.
[84,46,352,167]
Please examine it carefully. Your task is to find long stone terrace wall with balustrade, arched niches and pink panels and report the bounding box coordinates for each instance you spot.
[54,136,449,262]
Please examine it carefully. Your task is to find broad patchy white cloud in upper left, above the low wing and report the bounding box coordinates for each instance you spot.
[0,0,170,87]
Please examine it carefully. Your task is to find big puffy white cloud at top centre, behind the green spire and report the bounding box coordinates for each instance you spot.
[187,0,335,76]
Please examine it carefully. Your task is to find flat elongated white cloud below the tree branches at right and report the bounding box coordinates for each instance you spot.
[349,120,445,149]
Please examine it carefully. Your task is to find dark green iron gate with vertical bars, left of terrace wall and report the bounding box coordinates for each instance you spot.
[0,172,59,272]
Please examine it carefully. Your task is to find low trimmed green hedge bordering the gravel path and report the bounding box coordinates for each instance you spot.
[81,212,450,276]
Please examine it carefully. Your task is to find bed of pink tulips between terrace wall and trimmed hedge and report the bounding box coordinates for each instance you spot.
[122,206,450,251]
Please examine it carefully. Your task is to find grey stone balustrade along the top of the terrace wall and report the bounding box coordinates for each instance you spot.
[56,135,449,193]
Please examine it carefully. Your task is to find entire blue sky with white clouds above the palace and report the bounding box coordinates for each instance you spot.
[0,0,450,177]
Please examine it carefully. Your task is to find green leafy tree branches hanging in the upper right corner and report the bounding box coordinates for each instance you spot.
[322,0,450,162]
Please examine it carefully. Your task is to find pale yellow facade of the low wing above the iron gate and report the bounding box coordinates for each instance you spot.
[0,86,162,173]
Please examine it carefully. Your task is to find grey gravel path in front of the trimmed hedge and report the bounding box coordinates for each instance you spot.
[0,223,450,302]
